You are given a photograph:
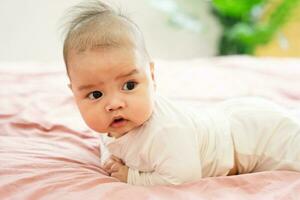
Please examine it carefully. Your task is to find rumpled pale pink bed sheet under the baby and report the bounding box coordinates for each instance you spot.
[0,57,300,200]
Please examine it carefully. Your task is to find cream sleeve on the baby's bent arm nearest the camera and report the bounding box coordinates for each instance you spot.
[127,126,201,185]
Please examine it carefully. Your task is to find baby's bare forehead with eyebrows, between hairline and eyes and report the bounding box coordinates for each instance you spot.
[69,51,149,91]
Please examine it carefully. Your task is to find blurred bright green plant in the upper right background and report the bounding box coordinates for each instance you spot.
[212,0,298,55]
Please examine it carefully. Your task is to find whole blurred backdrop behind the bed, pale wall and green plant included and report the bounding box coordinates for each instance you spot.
[0,0,300,62]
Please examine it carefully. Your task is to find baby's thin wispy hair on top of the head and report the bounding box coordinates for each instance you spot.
[63,0,150,75]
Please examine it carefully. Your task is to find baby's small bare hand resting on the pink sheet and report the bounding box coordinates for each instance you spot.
[103,156,128,183]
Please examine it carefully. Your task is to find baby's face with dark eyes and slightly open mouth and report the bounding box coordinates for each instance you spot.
[68,48,154,138]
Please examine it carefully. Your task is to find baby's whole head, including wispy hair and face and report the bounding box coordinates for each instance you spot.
[64,1,155,137]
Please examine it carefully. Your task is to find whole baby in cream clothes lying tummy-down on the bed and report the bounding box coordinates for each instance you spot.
[64,1,300,185]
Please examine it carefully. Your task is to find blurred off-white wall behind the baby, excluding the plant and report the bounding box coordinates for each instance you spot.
[0,0,219,62]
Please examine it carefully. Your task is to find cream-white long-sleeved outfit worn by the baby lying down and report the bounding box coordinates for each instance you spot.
[102,96,300,185]
